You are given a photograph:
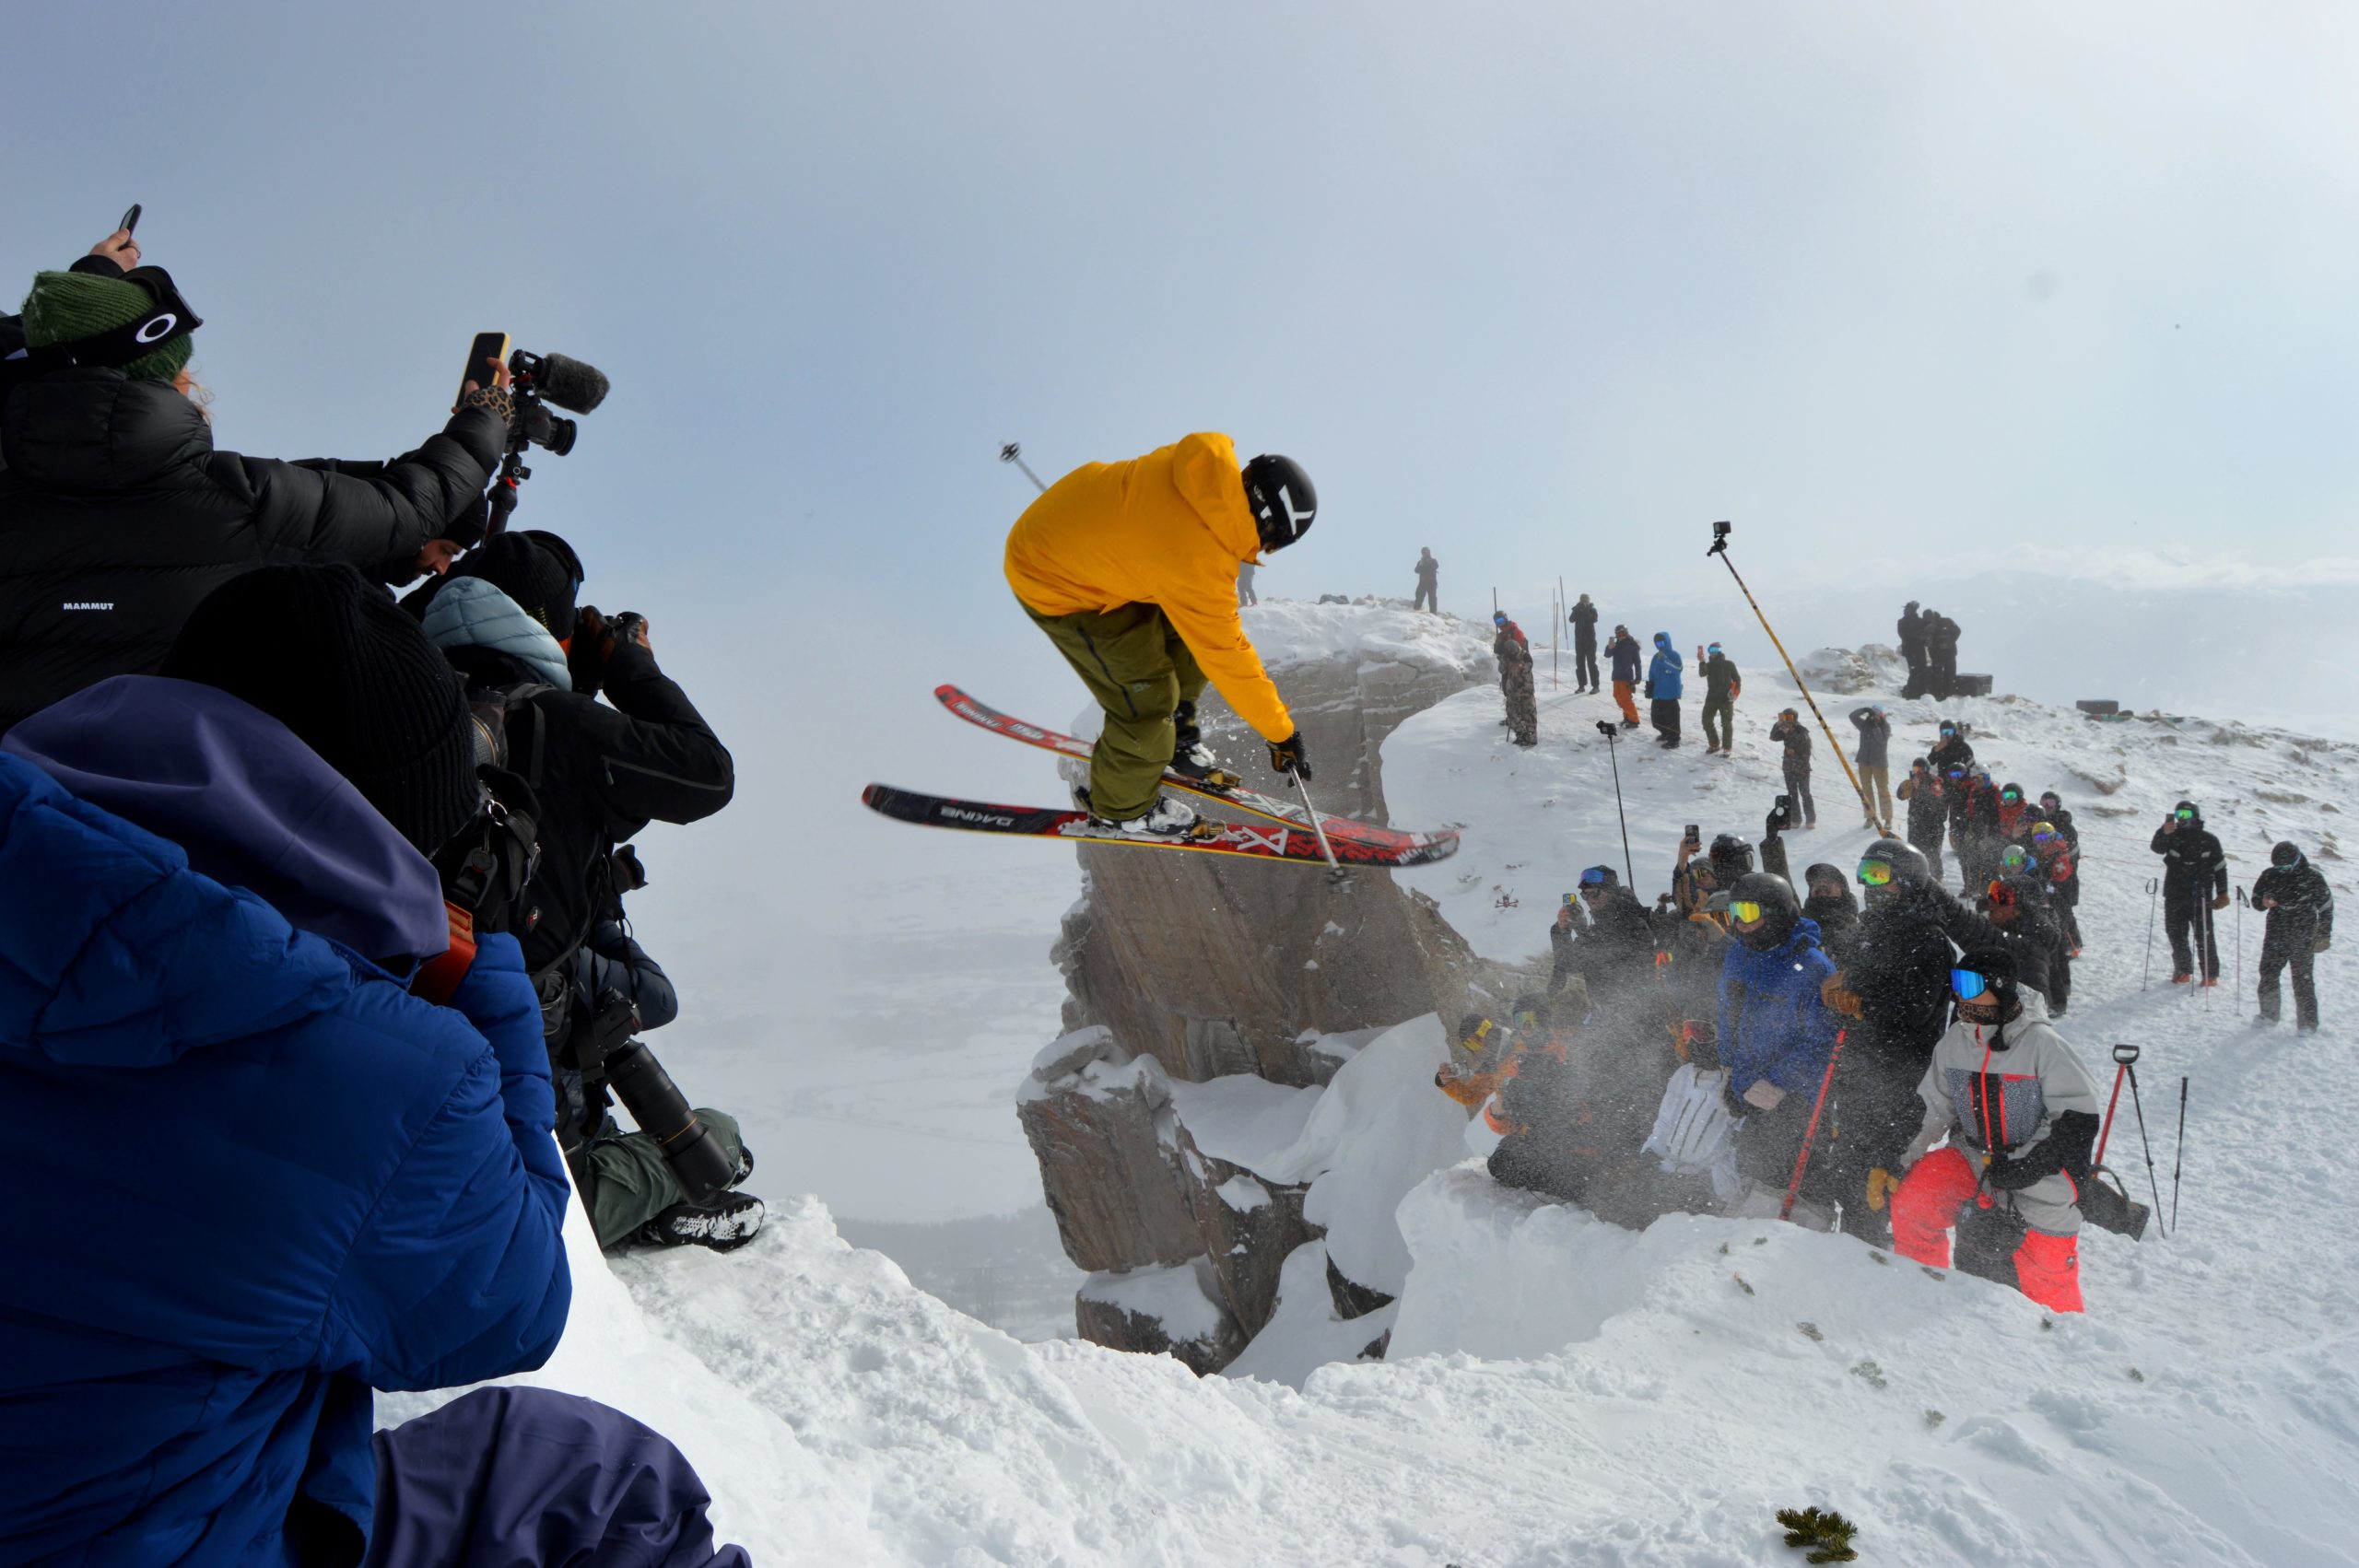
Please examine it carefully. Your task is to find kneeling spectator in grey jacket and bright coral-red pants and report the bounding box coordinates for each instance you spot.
[1869,948,2097,1311]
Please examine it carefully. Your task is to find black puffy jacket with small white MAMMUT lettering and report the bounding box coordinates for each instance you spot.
[0,368,507,731]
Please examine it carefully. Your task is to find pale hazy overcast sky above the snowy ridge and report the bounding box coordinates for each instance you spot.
[18,0,2359,1207]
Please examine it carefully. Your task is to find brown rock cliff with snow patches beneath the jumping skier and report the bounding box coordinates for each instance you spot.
[1021,603,1505,1370]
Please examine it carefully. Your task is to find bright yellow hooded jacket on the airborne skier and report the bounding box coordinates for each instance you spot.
[1007,431,1295,741]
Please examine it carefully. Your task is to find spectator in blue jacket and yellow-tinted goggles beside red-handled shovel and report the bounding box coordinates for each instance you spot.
[1719,872,1836,1196]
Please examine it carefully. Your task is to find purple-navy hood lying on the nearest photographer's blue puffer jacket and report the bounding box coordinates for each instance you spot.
[0,674,451,960]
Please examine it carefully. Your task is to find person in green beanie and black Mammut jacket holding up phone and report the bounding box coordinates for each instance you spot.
[0,207,512,729]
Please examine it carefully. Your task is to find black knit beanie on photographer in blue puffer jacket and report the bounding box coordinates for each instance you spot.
[160,566,479,854]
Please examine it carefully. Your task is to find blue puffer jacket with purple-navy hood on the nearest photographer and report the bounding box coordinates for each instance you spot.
[0,677,571,1565]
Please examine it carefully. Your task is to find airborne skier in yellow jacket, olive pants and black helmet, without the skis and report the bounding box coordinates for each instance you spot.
[1007,431,1319,837]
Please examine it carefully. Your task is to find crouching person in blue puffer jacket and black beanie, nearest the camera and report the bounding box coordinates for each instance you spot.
[0,566,741,1565]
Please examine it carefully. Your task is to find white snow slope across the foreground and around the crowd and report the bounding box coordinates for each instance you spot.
[424,641,2359,1568]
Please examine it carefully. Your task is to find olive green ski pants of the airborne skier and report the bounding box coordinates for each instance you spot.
[1019,599,1205,823]
